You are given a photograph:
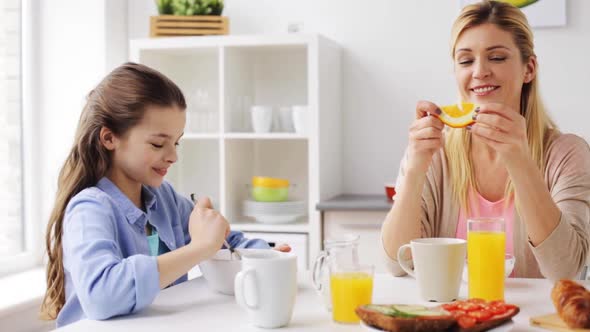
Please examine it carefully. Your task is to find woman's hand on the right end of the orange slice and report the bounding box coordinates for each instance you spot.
[470,103,529,164]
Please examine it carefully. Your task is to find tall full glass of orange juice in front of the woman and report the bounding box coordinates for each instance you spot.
[467,218,506,301]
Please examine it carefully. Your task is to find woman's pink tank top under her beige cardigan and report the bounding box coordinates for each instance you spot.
[455,190,514,255]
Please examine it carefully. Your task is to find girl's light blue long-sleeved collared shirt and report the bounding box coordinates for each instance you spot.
[57,178,269,327]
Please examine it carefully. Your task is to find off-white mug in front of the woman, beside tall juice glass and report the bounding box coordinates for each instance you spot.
[397,238,467,302]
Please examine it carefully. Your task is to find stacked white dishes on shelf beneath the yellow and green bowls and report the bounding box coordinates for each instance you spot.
[243,200,307,224]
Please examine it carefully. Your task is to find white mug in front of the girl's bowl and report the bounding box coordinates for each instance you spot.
[234,249,297,328]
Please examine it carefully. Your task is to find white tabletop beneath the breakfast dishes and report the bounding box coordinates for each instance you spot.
[53,273,590,332]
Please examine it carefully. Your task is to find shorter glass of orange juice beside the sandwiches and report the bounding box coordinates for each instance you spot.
[330,264,374,323]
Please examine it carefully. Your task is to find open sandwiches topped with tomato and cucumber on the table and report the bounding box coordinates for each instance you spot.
[356,299,520,332]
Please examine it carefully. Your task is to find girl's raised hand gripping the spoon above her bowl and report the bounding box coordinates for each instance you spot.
[188,197,230,257]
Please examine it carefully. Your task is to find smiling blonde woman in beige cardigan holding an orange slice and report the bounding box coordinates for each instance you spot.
[382,1,590,279]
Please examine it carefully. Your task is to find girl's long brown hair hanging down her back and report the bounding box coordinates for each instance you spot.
[40,63,186,320]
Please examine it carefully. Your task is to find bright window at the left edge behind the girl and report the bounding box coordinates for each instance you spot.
[0,0,39,277]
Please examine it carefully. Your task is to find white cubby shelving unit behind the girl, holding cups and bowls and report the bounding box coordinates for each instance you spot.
[130,34,342,263]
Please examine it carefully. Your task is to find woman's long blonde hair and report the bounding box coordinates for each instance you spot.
[445,1,557,211]
